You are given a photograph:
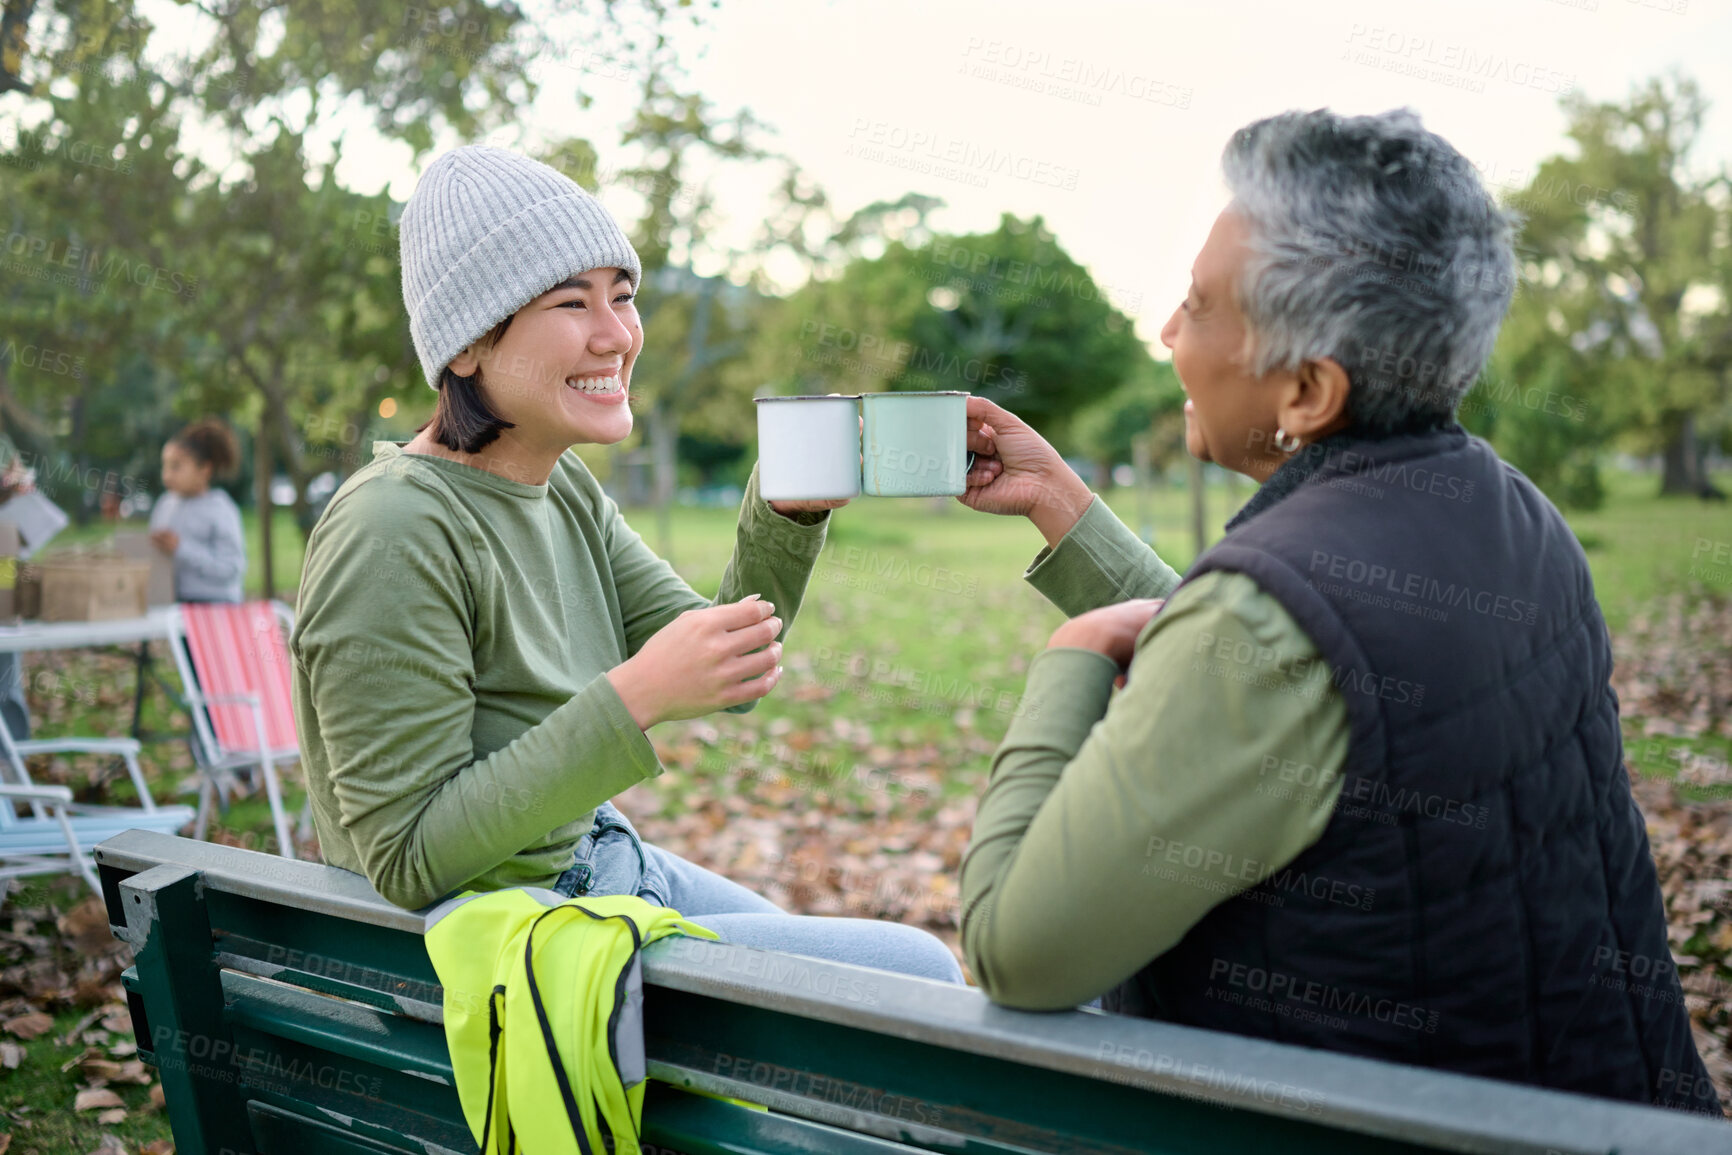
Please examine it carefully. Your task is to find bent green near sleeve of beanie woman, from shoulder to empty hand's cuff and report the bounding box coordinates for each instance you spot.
[293,478,662,909]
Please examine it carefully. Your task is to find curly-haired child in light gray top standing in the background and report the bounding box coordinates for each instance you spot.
[151,417,246,601]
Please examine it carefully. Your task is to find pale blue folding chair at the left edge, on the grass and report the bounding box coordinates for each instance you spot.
[0,722,192,894]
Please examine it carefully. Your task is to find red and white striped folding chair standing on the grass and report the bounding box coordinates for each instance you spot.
[170,601,301,859]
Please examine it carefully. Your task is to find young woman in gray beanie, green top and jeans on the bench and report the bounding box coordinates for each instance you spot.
[291,147,961,982]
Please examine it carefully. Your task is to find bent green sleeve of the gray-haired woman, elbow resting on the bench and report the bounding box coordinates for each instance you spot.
[961,573,1349,1010]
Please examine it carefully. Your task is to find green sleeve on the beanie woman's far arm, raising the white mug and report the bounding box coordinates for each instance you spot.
[598,468,830,713]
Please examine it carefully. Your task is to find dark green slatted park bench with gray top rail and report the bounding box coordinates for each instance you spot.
[95,831,1732,1155]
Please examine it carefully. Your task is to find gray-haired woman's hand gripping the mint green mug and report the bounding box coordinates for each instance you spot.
[956,397,1095,545]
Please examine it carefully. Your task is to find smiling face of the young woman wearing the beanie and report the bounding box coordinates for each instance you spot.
[450,268,644,454]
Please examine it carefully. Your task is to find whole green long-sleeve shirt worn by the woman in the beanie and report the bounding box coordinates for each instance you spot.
[291,442,826,907]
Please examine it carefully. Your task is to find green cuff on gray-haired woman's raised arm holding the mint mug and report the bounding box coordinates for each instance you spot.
[1022,495,1179,618]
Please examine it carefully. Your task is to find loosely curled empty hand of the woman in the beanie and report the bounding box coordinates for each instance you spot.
[608,594,781,731]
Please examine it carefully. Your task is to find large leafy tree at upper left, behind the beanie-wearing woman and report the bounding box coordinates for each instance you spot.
[0,0,710,592]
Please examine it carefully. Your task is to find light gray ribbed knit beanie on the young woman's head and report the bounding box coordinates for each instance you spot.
[397,144,643,390]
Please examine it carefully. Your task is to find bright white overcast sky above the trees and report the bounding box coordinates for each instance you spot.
[159,0,1732,341]
